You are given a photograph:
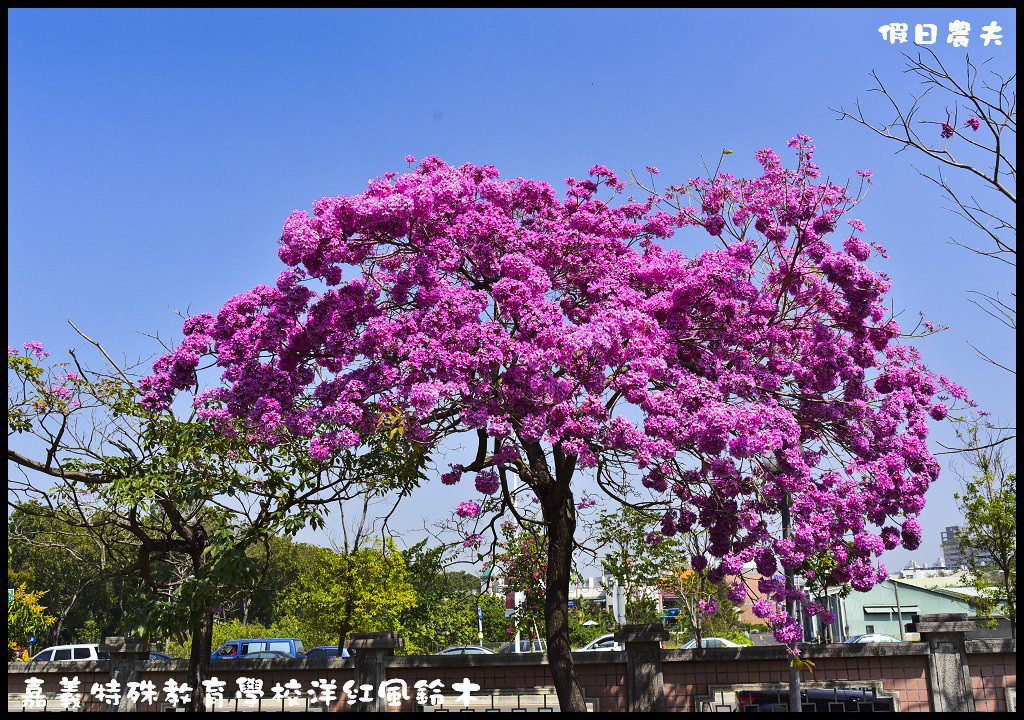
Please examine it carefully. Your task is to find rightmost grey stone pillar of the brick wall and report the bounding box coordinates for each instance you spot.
[906,612,977,713]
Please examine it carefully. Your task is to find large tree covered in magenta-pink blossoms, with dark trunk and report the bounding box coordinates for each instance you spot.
[141,135,967,710]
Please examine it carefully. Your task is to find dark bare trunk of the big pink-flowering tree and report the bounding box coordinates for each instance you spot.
[540,488,587,713]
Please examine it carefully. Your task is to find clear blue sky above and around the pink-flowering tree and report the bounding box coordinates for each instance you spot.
[7,8,1016,569]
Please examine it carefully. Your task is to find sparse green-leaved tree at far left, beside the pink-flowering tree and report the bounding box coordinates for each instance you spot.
[7,336,425,712]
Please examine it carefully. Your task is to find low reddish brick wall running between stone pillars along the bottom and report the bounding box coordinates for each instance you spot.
[7,640,1017,712]
